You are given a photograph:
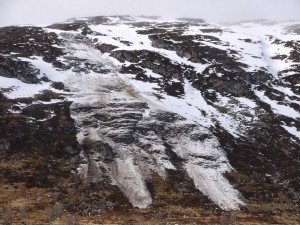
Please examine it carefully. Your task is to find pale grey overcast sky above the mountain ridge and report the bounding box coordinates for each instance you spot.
[0,0,300,26]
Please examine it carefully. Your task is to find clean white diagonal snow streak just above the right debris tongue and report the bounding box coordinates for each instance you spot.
[122,75,257,137]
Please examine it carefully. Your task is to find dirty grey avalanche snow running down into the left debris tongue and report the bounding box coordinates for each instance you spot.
[61,37,175,208]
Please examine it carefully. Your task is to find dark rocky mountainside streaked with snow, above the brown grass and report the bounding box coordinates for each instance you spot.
[0,16,300,223]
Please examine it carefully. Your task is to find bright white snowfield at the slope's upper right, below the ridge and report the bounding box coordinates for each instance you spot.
[226,23,300,76]
